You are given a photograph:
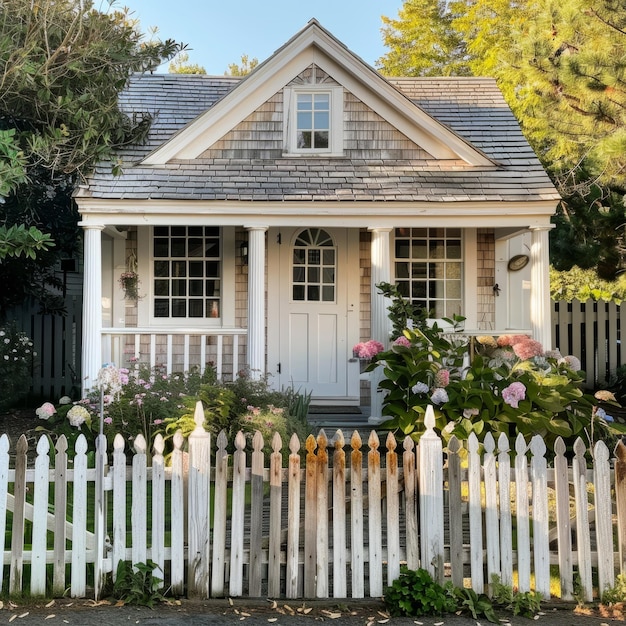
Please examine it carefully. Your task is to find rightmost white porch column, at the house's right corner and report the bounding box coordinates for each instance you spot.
[530,226,553,350]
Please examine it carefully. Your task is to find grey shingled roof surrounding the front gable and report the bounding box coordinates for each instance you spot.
[77,74,559,202]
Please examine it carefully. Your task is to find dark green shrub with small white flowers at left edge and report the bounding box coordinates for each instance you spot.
[0,324,37,410]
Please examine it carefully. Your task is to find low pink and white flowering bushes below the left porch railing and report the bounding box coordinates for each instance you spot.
[36,364,306,451]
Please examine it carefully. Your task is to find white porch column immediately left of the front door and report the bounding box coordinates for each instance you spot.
[245,226,267,380]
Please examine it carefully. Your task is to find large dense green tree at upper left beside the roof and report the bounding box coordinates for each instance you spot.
[0,0,182,315]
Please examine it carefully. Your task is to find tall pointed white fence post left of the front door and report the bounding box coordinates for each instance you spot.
[187,401,211,598]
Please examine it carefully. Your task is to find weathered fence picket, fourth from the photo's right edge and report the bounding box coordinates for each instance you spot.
[554,437,574,600]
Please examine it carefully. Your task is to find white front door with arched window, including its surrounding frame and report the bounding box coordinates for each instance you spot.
[268,228,359,404]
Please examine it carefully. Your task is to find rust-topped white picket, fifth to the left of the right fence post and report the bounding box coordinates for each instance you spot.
[332,430,348,598]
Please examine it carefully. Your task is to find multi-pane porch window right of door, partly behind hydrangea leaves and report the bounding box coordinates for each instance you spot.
[394,228,463,318]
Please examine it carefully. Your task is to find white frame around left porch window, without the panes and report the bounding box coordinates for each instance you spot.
[137,227,236,329]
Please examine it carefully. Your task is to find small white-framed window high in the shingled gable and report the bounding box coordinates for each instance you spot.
[284,85,343,156]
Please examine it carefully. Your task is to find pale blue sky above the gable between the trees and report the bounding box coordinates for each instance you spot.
[107,0,402,75]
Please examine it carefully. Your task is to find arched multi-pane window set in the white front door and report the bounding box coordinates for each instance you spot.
[291,228,337,302]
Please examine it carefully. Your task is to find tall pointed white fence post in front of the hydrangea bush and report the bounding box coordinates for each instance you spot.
[418,405,444,584]
